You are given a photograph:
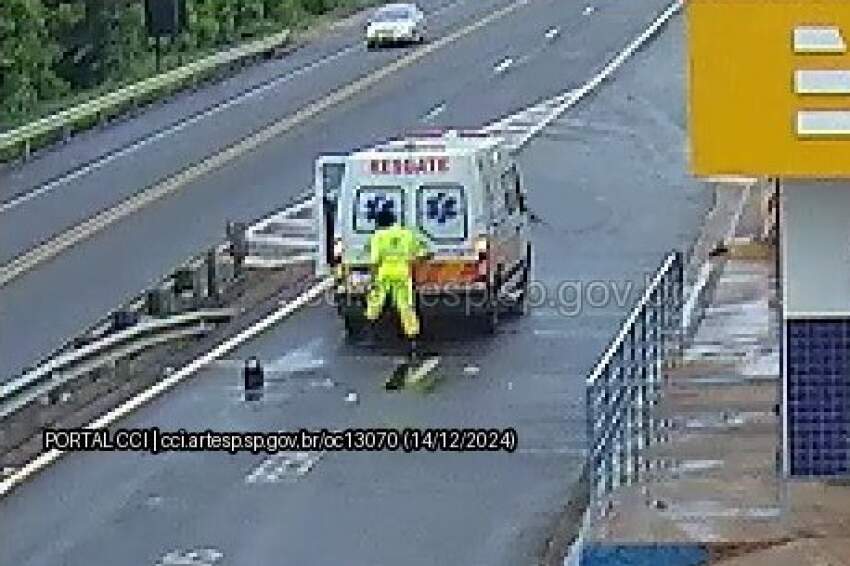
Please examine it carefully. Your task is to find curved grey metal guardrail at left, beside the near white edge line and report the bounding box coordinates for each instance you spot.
[0,309,234,419]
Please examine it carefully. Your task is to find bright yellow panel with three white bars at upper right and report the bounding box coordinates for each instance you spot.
[685,0,850,177]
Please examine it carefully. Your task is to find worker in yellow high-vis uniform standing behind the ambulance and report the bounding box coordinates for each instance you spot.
[366,204,430,355]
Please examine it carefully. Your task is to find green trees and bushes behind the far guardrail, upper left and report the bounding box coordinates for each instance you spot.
[0,0,373,131]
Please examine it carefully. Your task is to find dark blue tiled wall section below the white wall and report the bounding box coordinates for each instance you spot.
[785,319,850,476]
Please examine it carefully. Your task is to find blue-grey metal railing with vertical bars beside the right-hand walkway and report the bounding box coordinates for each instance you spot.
[585,251,685,505]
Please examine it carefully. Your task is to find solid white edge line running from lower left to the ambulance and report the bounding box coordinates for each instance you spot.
[0,278,333,496]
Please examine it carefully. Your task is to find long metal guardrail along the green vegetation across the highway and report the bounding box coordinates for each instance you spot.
[0,30,290,160]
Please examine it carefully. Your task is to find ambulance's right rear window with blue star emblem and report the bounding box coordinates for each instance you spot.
[416,183,469,242]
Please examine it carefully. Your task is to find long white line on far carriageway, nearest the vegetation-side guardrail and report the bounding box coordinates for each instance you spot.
[0,44,361,213]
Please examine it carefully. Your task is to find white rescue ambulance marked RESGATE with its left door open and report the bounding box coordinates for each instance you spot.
[315,130,531,336]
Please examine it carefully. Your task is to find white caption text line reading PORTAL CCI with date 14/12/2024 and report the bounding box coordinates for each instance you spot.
[42,427,519,454]
